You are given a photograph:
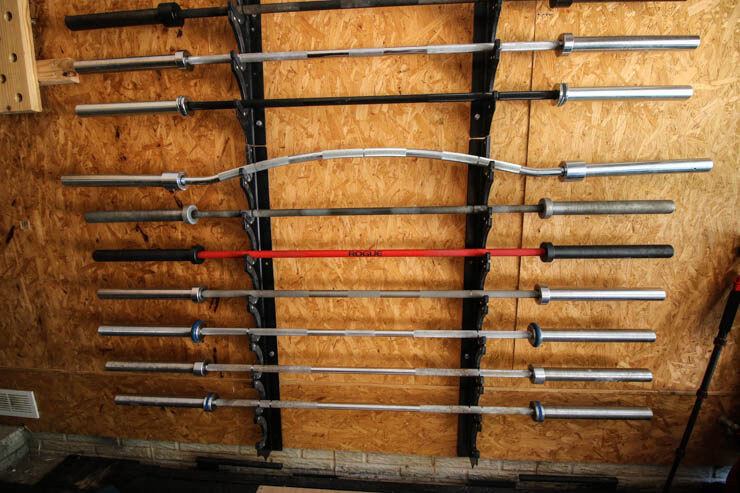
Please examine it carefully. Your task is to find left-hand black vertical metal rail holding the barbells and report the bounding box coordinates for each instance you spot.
[227,0,283,458]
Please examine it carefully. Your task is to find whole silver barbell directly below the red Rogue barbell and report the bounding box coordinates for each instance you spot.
[98,285,666,305]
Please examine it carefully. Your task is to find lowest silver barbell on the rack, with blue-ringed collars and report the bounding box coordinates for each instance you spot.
[115,393,653,422]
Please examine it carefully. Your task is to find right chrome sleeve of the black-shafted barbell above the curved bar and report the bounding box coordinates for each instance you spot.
[556,83,694,106]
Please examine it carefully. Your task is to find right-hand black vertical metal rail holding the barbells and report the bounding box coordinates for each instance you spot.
[457,0,503,466]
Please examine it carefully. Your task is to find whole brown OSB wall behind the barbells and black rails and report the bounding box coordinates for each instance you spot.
[0,0,740,463]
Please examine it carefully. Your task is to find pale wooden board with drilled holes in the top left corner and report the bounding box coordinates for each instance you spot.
[0,0,41,113]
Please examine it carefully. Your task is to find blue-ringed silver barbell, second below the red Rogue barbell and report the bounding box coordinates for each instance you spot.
[98,320,656,347]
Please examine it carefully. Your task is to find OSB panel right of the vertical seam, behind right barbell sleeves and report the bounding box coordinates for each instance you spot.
[517,1,740,390]
